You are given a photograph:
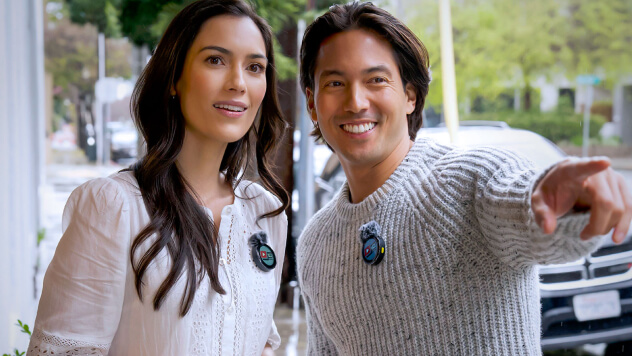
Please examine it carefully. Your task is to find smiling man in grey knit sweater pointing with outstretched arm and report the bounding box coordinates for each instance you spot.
[297,2,632,355]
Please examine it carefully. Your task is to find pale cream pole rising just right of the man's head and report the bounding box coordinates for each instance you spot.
[439,0,459,143]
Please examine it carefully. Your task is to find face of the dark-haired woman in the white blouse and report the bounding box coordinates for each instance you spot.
[172,15,268,143]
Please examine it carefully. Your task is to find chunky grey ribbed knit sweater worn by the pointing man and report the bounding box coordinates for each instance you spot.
[297,139,599,356]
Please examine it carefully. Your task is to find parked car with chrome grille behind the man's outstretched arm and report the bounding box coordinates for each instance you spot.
[315,121,632,354]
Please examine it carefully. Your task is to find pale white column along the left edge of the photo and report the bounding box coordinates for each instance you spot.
[0,0,44,353]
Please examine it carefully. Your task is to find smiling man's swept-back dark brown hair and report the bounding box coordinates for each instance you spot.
[301,1,430,141]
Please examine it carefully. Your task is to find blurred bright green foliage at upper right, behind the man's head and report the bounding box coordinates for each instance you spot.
[406,0,632,110]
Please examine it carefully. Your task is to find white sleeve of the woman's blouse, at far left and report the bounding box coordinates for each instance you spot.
[28,178,130,355]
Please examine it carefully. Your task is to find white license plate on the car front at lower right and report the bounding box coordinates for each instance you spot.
[573,290,621,321]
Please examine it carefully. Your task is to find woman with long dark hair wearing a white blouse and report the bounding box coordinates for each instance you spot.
[29,0,288,356]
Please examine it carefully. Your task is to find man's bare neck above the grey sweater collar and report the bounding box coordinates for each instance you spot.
[341,140,413,204]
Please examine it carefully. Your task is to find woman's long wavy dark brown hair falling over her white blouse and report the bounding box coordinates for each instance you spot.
[130,0,289,316]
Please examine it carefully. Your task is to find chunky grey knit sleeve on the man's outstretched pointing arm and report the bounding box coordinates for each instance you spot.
[446,148,600,267]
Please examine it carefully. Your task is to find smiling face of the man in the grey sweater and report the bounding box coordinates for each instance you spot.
[306,29,416,170]
